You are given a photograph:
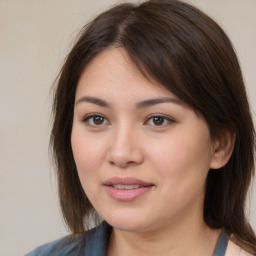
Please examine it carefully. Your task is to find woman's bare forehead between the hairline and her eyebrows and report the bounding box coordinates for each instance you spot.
[76,48,178,101]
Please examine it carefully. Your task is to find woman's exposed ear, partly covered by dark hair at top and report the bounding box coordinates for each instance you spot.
[210,127,236,169]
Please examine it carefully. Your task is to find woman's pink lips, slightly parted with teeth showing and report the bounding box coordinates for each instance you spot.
[104,177,154,202]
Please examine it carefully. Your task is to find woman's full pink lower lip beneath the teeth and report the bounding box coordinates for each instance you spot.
[105,186,153,202]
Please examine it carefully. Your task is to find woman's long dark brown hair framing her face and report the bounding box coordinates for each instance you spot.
[51,0,256,253]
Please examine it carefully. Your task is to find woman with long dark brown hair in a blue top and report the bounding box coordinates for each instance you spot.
[28,0,256,256]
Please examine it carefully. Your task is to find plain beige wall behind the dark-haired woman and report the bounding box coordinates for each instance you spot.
[0,0,256,256]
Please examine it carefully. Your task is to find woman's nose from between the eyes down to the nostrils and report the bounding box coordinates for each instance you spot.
[107,126,144,168]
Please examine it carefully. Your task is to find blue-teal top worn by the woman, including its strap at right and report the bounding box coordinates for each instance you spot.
[25,222,228,256]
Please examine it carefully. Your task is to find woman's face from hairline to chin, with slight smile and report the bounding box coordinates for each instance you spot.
[71,48,217,231]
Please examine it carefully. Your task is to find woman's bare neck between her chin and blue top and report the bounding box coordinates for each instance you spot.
[107,211,220,256]
